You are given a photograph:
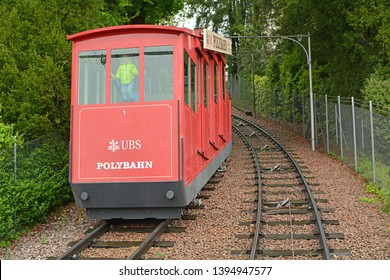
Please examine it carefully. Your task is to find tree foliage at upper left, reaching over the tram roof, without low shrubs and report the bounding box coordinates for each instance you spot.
[0,0,183,140]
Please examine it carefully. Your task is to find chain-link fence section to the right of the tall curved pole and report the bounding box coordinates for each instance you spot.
[316,96,390,188]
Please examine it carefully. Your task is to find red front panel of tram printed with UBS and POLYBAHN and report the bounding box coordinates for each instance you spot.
[72,104,178,182]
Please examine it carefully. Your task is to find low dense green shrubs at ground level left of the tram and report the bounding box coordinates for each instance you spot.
[0,130,72,246]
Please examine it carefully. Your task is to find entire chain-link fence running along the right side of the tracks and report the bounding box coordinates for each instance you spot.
[230,84,390,188]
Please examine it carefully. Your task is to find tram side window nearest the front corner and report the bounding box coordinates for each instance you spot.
[184,51,196,112]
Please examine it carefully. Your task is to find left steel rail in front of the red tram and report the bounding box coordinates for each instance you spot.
[57,221,112,260]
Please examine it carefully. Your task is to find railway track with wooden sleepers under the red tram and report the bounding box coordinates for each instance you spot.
[50,163,227,260]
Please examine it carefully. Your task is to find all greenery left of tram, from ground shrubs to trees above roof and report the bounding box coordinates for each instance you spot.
[0,0,187,246]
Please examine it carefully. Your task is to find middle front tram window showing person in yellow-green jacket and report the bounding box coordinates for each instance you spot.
[110,48,139,103]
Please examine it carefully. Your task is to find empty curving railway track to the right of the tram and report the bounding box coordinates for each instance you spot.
[232,115,349,260]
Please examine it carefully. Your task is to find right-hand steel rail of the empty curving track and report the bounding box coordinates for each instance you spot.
[233,114,331,260]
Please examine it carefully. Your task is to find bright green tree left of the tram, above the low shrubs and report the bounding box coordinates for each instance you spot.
[0,0,70,138]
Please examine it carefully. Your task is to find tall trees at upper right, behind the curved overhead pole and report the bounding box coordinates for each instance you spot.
[187,0,390,106]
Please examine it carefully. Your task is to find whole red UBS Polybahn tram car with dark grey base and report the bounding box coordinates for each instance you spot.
[68,25,232,219]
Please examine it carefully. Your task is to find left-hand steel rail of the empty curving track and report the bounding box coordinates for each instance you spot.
[233,125,263,260]
